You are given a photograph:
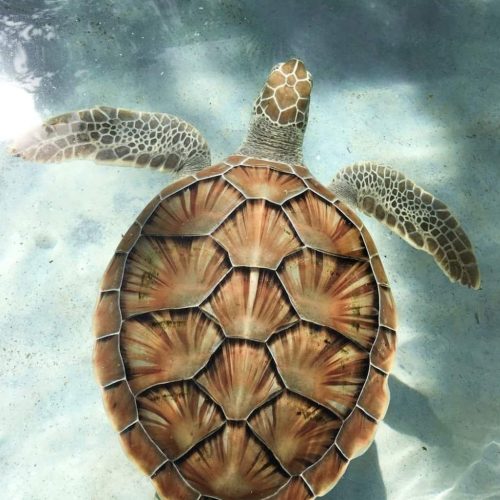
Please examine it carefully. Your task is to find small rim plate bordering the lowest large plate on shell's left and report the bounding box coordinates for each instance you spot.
[120,423,166,476]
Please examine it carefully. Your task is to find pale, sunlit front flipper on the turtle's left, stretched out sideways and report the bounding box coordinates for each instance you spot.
[11,106,210,174]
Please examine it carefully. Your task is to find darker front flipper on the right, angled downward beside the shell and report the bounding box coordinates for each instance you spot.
[330,163,481,289]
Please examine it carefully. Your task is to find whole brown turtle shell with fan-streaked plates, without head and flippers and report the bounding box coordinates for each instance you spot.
[94,156,396,500]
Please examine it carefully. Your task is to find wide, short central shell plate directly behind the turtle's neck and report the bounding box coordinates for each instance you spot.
[225,167,306,204]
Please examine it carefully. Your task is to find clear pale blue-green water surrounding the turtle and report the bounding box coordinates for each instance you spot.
[0,0,500,500]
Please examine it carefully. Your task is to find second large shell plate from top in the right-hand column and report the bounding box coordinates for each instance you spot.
[278,249,378,349]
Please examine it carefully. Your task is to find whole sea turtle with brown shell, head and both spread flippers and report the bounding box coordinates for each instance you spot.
[12,59,480,500]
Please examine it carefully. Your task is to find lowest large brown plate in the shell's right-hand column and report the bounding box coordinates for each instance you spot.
[249,391,342,475]
